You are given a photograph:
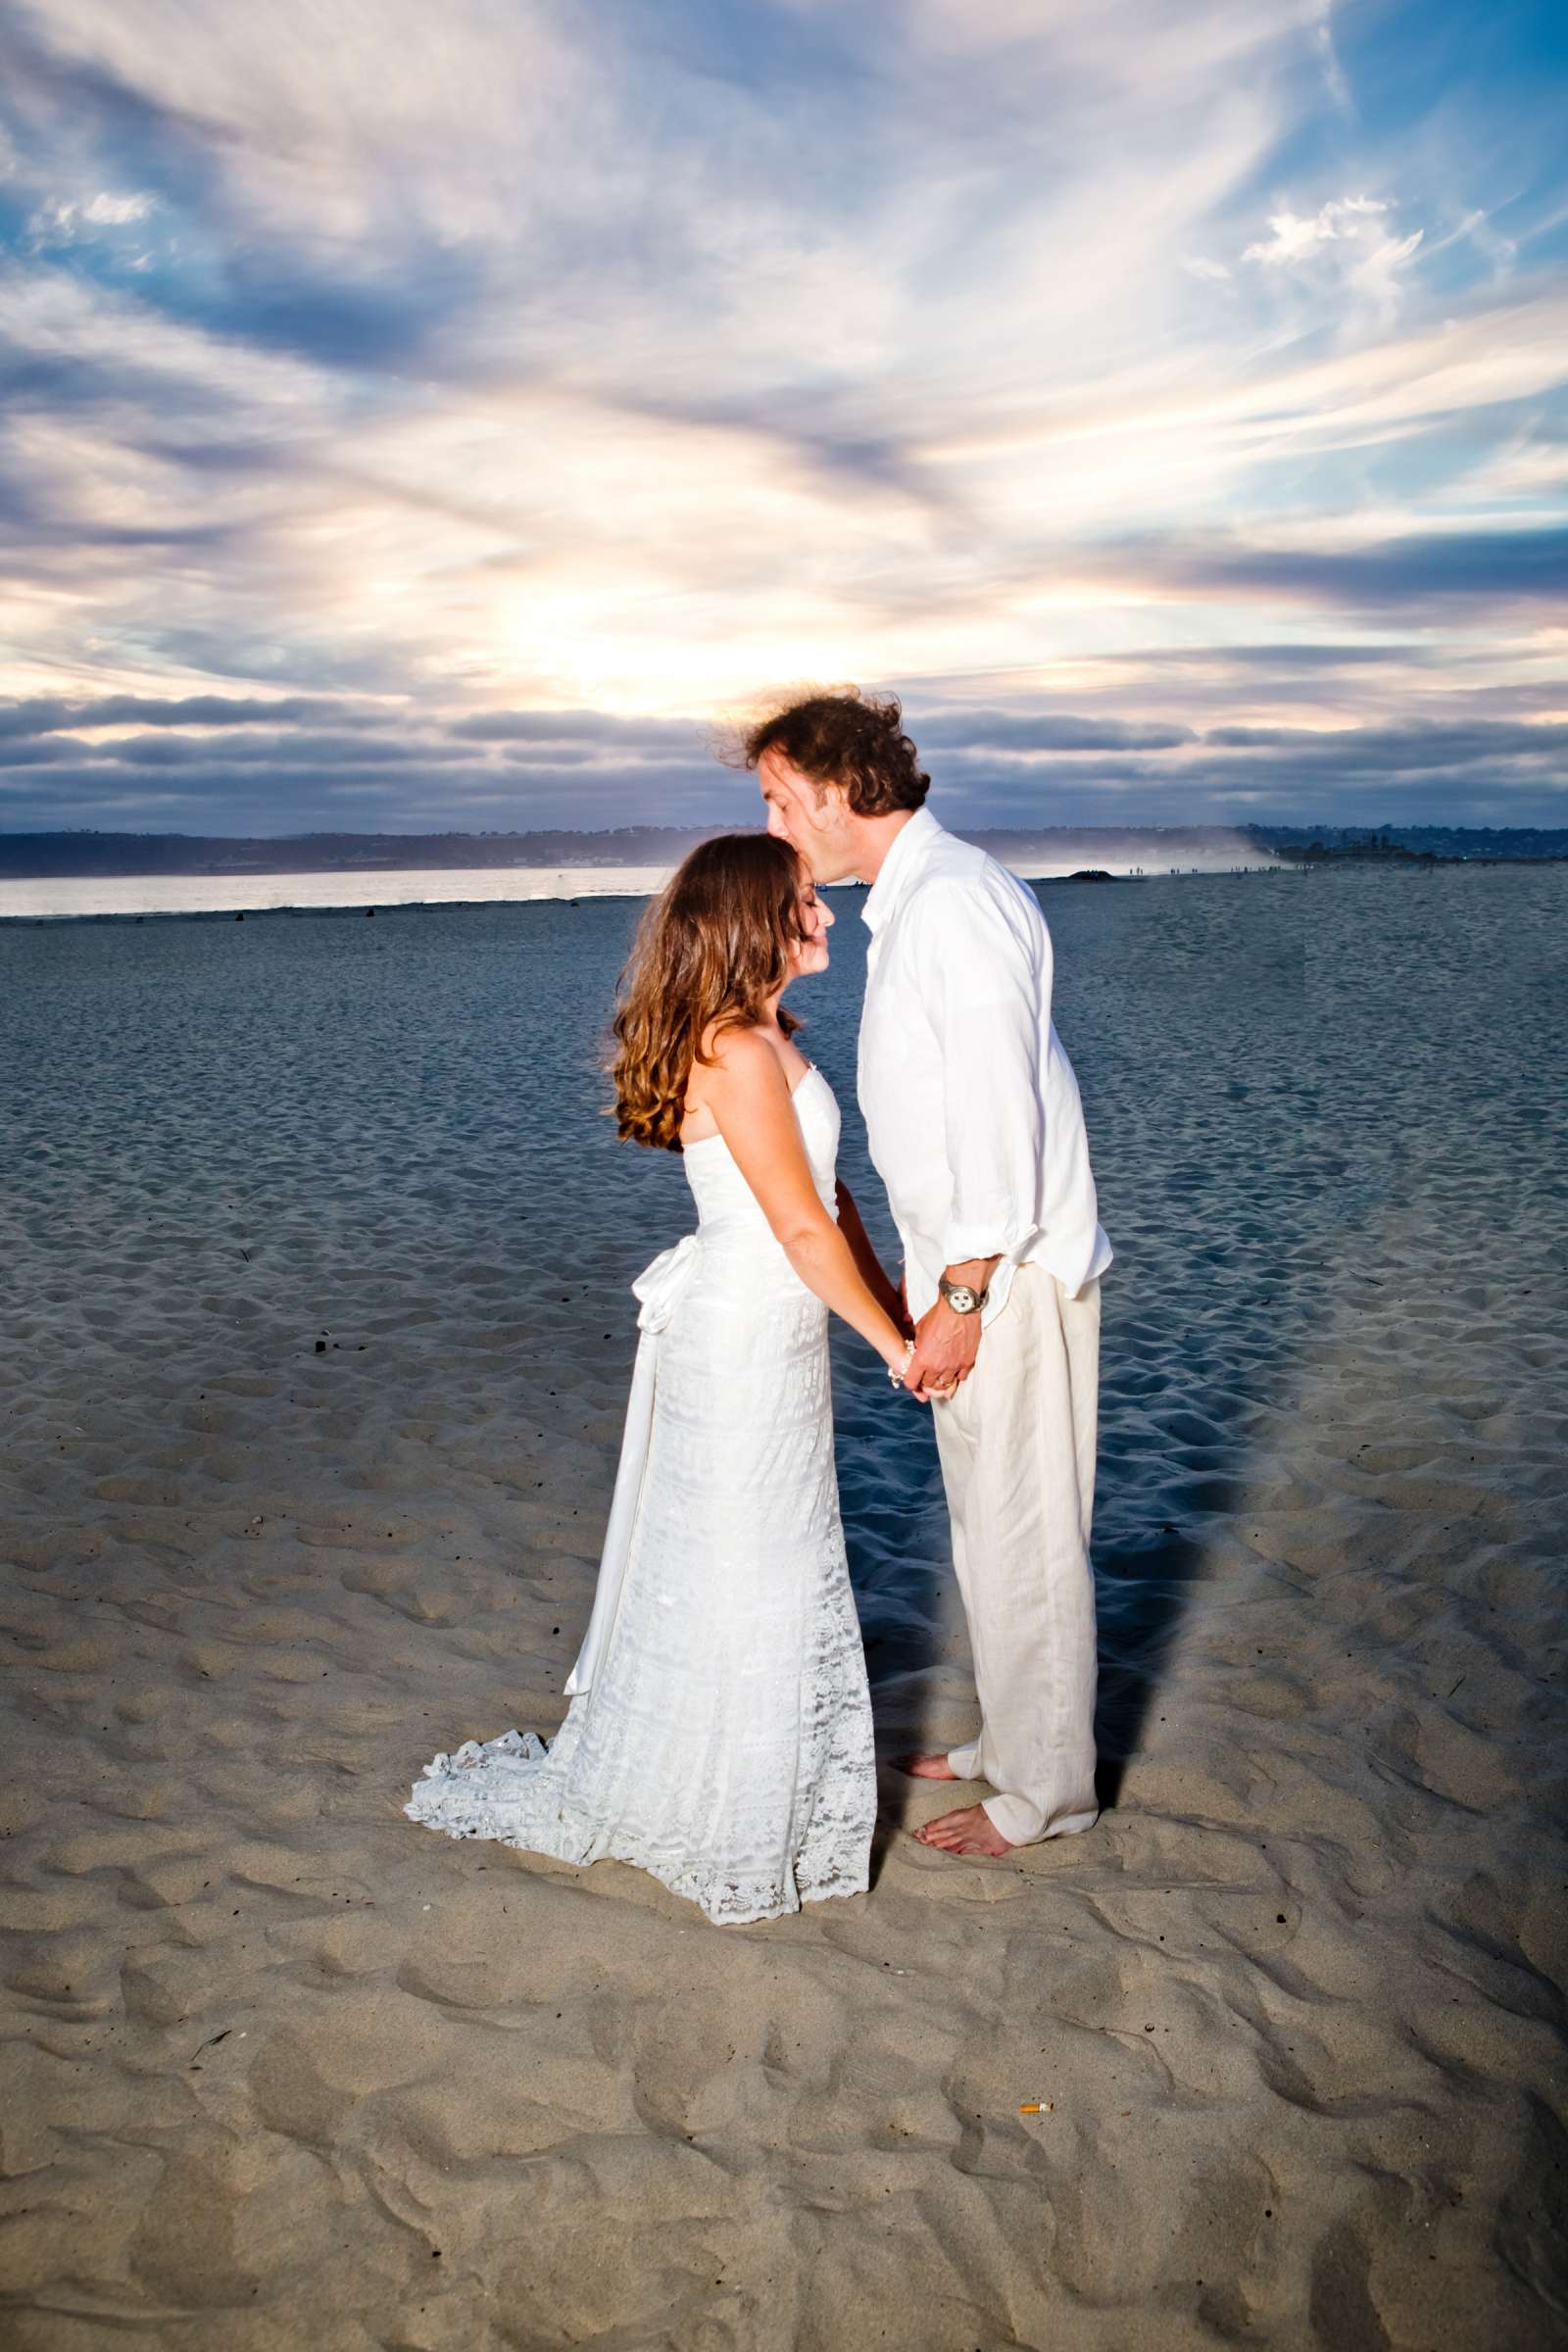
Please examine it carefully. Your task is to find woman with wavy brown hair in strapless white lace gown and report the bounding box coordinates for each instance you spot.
[405,833,909,1924]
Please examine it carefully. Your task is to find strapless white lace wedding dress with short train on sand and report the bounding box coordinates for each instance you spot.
[405,1068,877,1924]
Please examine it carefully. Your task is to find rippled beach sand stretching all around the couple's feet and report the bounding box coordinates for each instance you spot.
[0,870,1568,2352]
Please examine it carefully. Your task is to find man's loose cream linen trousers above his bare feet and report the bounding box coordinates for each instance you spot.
[933,1265,1101,1846]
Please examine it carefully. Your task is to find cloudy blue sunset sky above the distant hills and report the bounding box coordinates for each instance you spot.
[0,0,1568,835]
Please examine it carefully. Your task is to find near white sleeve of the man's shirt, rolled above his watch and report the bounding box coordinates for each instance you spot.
[909,880,1051,1265]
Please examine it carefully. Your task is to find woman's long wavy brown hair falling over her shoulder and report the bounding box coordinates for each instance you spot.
[612,833,804,1152]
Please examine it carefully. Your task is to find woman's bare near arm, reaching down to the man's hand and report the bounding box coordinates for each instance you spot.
[703,1030,906,1366]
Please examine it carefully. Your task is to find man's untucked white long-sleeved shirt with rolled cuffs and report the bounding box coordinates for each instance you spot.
[858,809,1112,1324]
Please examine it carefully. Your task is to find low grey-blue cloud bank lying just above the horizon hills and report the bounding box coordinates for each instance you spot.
[0,686,1568,835]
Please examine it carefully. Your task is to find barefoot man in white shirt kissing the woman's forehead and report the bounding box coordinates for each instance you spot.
[745,692,1109,1853]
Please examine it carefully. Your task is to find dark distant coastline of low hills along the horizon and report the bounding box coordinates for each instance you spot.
[12,825,1568,882]
